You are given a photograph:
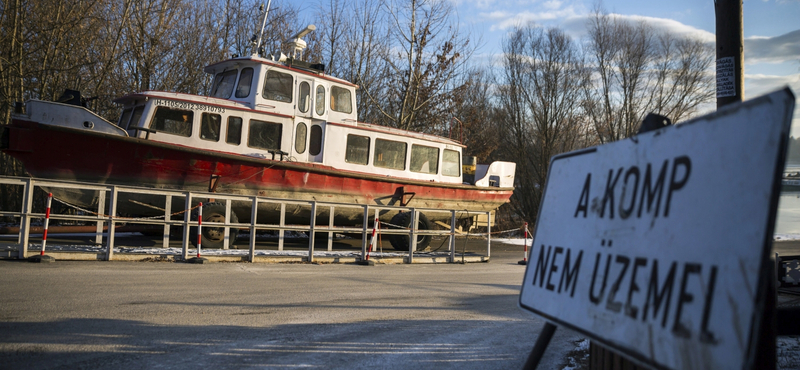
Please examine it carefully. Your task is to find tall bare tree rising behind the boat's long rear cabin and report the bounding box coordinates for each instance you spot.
[366,0,474,131]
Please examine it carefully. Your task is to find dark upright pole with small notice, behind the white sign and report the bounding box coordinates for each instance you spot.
[714,0,744,109]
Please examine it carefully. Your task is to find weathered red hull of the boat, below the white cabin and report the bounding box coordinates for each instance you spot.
[4,120,513,221]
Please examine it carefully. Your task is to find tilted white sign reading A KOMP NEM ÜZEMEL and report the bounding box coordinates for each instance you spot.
[520,89,795,369]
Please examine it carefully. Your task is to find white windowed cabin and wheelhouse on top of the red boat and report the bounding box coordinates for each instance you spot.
[115,56,488,186]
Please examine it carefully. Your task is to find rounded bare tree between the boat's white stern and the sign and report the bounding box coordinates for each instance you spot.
[498,24,588,222]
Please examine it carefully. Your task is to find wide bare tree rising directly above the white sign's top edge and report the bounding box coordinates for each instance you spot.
[583,9,713,143]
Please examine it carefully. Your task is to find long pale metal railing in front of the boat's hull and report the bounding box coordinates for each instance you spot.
[0,176,491,263]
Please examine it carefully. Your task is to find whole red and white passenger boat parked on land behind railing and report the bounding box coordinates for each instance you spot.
[0,16,515,250]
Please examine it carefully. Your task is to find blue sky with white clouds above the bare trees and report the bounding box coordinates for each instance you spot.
[289,0,800,137]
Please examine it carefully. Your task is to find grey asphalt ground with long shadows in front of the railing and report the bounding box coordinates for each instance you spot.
[0,238,582,369]
